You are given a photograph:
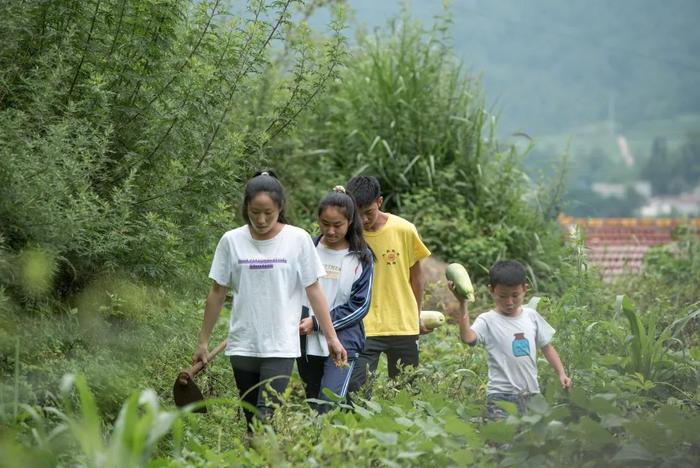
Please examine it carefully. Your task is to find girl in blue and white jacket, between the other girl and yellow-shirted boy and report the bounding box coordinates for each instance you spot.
[297,186,374,412]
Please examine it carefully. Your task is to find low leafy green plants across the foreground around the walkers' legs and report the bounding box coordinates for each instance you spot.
[0,236,700,466]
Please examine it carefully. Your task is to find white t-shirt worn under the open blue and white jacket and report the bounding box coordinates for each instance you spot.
[304,242,362,356]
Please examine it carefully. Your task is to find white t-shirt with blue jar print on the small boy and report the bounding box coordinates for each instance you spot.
[472,307,555,394]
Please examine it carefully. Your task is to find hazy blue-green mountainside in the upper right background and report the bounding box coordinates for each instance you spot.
[332,0,700,135]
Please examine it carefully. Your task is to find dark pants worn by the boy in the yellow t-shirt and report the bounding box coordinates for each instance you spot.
[348,335,418,398]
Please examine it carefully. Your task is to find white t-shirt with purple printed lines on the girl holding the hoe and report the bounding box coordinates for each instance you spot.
[209,224,326,357]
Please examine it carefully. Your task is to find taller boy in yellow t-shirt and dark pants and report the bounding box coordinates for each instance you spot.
[346,176,430,392]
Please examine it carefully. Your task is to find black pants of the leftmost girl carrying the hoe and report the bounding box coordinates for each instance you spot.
[230,356,294,431]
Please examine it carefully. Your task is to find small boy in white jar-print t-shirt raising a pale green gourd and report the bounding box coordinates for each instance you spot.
[448,260,571,419]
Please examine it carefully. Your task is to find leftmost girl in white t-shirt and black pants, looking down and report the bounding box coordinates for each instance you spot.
[192,172,347,431]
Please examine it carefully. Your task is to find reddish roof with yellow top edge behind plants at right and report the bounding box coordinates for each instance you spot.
[559,216,700,281]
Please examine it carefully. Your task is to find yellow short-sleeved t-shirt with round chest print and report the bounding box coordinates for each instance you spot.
[364,214,430,336]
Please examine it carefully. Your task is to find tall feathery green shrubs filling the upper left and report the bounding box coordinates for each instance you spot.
[0,0,343,295]
